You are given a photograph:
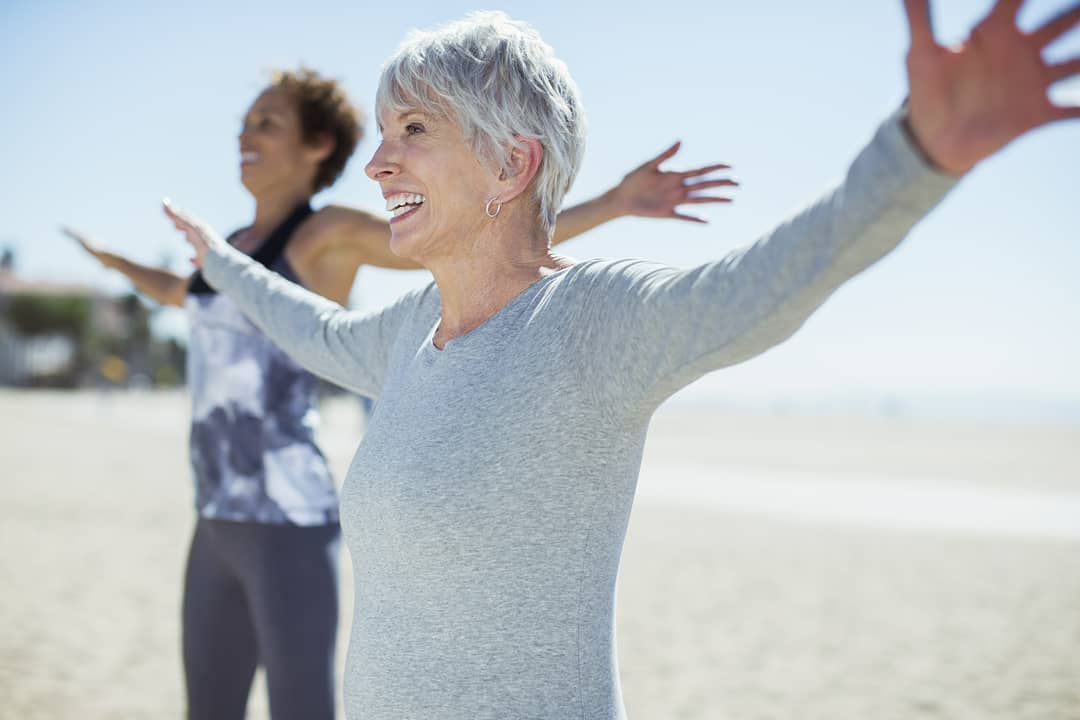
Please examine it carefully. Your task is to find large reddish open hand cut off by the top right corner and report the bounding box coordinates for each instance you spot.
[904,0,1080,176]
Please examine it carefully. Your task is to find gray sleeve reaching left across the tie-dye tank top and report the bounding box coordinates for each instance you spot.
[203,245,422,397]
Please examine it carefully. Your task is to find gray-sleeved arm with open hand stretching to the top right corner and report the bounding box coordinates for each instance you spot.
[582,0,1080,411]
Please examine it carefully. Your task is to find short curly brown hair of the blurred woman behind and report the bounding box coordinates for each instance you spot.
[270,67,364,192]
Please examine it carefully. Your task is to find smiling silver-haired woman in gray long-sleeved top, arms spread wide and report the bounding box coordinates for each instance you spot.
[166,0,1080,720]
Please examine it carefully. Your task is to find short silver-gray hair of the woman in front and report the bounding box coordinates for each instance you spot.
[375,11,585,234]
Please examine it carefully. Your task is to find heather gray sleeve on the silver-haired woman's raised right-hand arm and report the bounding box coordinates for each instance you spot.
[582,110,956,412]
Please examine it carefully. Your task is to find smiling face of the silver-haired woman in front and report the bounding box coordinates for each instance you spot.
[365,108,499,262]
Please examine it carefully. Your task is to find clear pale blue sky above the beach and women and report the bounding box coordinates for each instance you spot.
[0,0,1080,418]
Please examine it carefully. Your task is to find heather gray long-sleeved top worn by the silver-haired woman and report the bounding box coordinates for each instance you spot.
[205,110,953,720]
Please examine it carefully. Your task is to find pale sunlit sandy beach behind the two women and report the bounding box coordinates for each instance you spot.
[0,391,1080,720]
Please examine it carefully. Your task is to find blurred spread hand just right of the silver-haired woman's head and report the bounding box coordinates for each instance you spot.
[612,142,739,222]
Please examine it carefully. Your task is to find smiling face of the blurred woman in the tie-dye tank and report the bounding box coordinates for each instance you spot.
[240,87,325,196]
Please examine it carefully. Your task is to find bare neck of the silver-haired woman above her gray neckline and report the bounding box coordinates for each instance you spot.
[422,209,572,348]
